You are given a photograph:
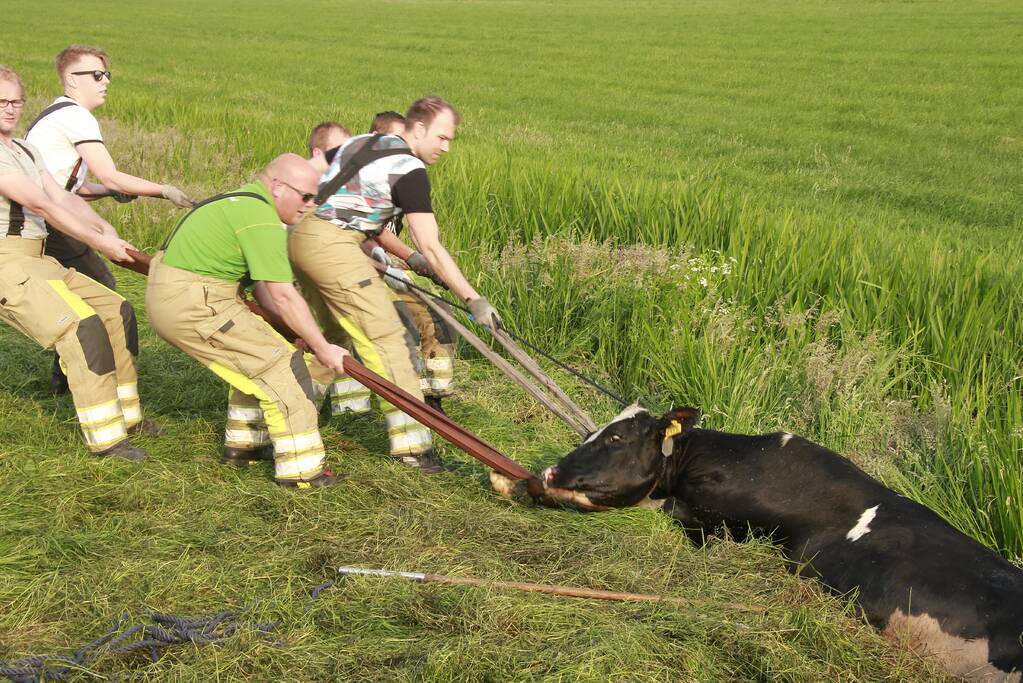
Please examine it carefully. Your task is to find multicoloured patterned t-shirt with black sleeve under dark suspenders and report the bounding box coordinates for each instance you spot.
[316,135,433,234]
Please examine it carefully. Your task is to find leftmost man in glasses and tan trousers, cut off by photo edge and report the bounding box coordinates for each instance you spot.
[0,65,147,461]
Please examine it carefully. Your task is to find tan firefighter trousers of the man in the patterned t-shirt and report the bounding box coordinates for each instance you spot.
[287,215,433,458]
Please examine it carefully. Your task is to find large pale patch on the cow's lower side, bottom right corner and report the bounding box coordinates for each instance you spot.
[884,609,1020,683]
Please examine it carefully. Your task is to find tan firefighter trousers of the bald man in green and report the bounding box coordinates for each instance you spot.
[145,252,332,482]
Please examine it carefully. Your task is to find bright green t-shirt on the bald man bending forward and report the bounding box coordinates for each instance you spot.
[164,182,295,282]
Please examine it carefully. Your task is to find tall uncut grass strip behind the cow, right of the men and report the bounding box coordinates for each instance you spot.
[437,160,1023,558]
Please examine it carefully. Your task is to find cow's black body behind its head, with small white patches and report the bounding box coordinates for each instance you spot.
[670,429,1023,680]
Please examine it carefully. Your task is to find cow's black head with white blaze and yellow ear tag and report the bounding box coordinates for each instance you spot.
[540,405,700,510]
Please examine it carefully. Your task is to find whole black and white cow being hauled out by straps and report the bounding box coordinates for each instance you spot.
[499,406,1023,681]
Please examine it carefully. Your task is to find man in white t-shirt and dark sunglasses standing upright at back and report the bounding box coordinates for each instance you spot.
[26,45,192,394]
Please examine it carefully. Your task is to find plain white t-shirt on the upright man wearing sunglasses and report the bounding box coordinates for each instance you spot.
[25,97,103,192]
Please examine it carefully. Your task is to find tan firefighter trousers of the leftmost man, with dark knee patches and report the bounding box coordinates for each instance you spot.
[0,235,142,453]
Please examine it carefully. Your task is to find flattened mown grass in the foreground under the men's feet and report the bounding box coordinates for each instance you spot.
[0,276,949,681]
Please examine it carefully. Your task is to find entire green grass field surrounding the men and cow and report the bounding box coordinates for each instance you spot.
[0,0,1023,681]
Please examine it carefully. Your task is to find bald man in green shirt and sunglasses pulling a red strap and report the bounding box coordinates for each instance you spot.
[145,154,347,488]
